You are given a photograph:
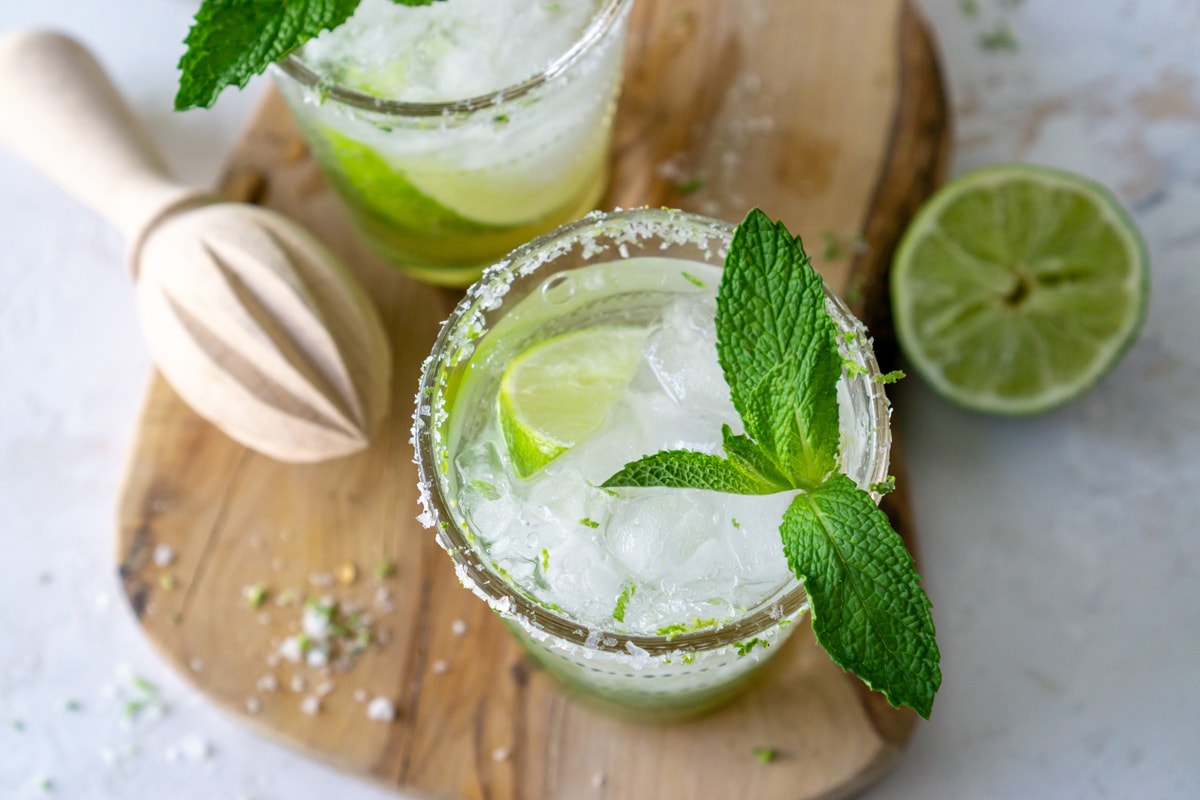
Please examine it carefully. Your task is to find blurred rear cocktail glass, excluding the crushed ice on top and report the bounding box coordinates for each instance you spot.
[272,0,632,287]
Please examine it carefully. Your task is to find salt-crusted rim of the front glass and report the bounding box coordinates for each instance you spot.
[413,207,892,657]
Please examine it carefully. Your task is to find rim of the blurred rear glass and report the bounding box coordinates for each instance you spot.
[275,0,634,116]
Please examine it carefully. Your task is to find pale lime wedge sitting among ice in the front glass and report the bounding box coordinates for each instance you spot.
[499,327,646,477]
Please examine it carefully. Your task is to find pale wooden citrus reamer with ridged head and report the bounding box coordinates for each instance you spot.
[0,31,391,462]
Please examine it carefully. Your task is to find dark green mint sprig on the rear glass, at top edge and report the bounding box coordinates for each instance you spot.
[175,0,444,112]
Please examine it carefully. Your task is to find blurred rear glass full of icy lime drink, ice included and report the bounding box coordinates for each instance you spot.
[274,0,632,285]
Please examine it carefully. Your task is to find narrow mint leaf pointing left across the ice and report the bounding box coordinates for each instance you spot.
[600,450,787,494]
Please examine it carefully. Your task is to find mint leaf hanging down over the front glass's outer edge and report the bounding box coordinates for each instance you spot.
[780,475,942,718]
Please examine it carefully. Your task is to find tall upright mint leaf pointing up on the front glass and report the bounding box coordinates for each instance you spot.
[716,209,841,487]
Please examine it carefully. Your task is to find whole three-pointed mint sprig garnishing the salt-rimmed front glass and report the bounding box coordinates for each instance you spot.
[604,209,942,718]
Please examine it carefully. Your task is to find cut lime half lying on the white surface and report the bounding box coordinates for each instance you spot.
[892,164,1148,414]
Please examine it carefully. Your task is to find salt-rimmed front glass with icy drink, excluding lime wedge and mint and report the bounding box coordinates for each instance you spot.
[415,210,890,718]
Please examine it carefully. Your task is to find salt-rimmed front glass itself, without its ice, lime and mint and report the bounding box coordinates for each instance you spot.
[414,209,890,720]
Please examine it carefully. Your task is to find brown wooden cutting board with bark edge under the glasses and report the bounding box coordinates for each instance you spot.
[116,0,947,800]
